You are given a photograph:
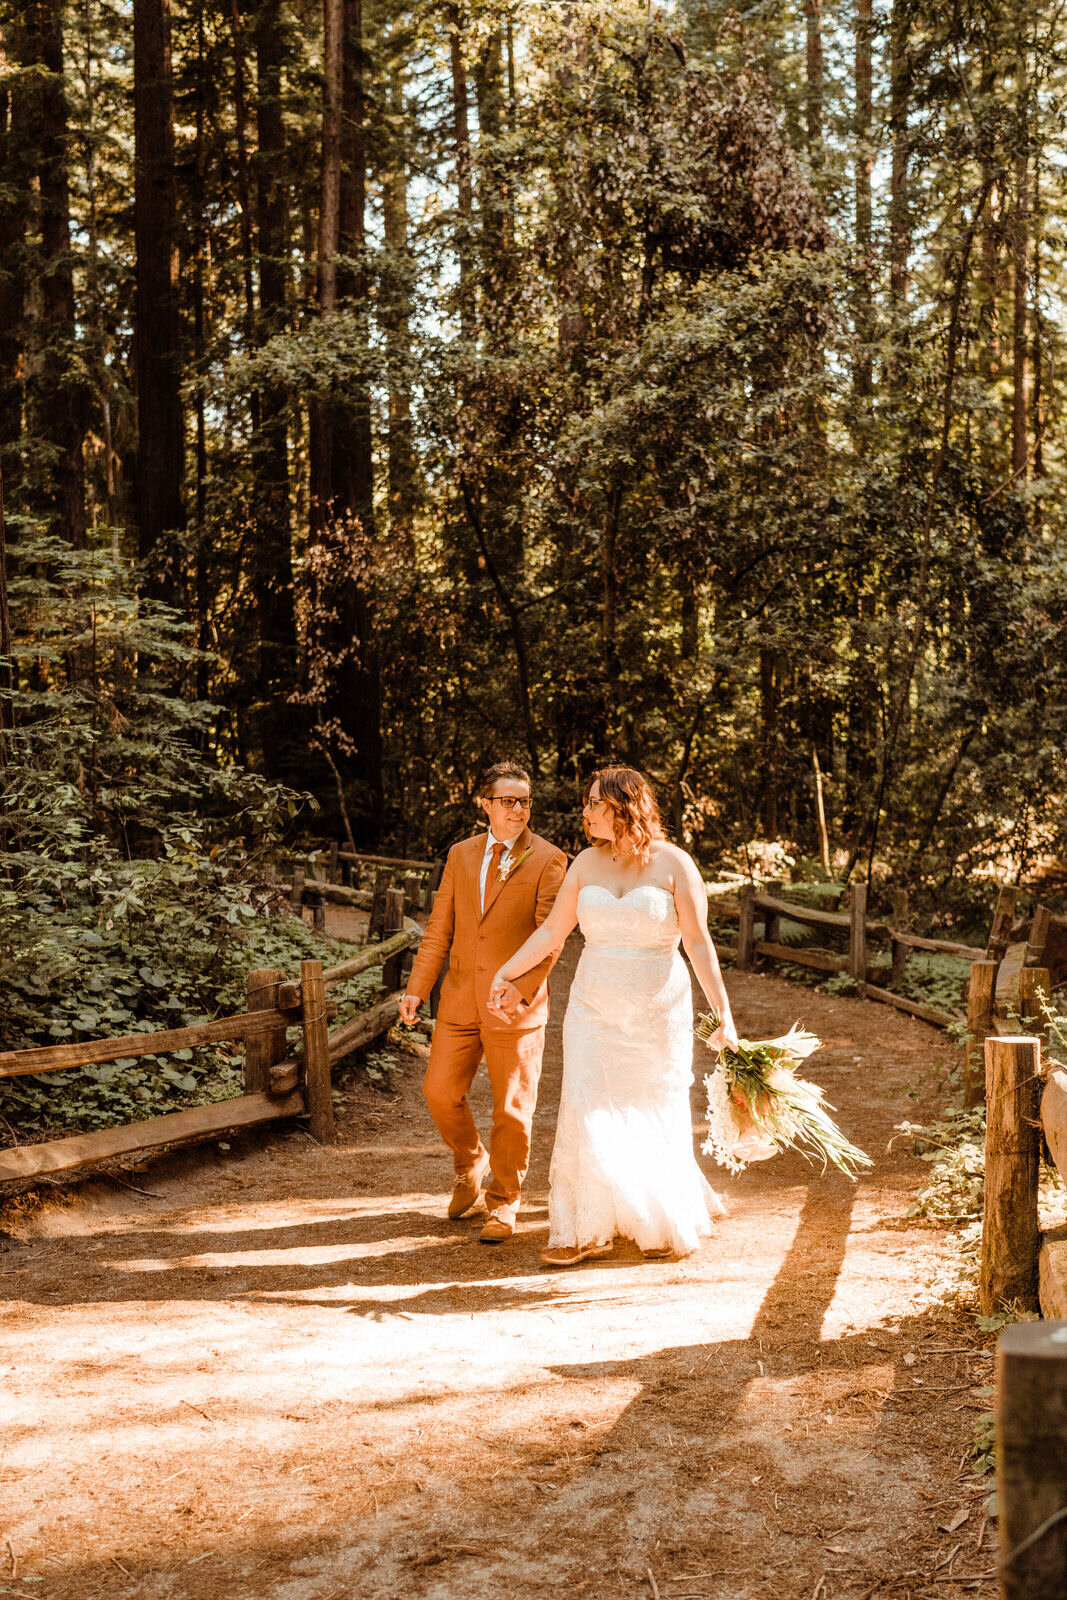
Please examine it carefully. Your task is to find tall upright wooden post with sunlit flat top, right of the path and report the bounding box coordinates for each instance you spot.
[979,1034,1041,1317]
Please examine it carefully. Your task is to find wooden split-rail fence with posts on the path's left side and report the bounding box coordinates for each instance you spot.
[0,918,421,1182]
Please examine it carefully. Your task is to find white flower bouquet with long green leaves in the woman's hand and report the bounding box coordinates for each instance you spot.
[696,1011,872,1179]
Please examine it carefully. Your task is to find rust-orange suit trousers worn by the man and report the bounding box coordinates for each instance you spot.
[422,1018,544,1210]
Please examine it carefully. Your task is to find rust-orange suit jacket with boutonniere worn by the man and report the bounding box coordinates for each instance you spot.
[408,827,566,1029]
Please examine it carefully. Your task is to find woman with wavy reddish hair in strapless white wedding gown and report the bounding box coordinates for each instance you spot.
[490,766,737,1267]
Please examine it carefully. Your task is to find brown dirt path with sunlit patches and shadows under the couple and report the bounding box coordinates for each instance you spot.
[0,950,993,1600]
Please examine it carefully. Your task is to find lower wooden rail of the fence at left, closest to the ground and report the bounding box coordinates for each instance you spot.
[0,1093,306,1182]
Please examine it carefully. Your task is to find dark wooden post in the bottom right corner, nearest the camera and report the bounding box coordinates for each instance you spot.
[995,1322,1067,1600]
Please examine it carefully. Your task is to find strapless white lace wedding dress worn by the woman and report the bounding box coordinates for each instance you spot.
[549,883,725,1256]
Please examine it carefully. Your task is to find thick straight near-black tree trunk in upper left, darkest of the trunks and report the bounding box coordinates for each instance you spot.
[133,0,186,600]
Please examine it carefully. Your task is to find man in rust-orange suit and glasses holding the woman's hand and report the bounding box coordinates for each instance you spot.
[400,762,566,1245]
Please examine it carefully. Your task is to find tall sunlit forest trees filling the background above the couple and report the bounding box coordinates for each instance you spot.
[0,0,1067,896]
